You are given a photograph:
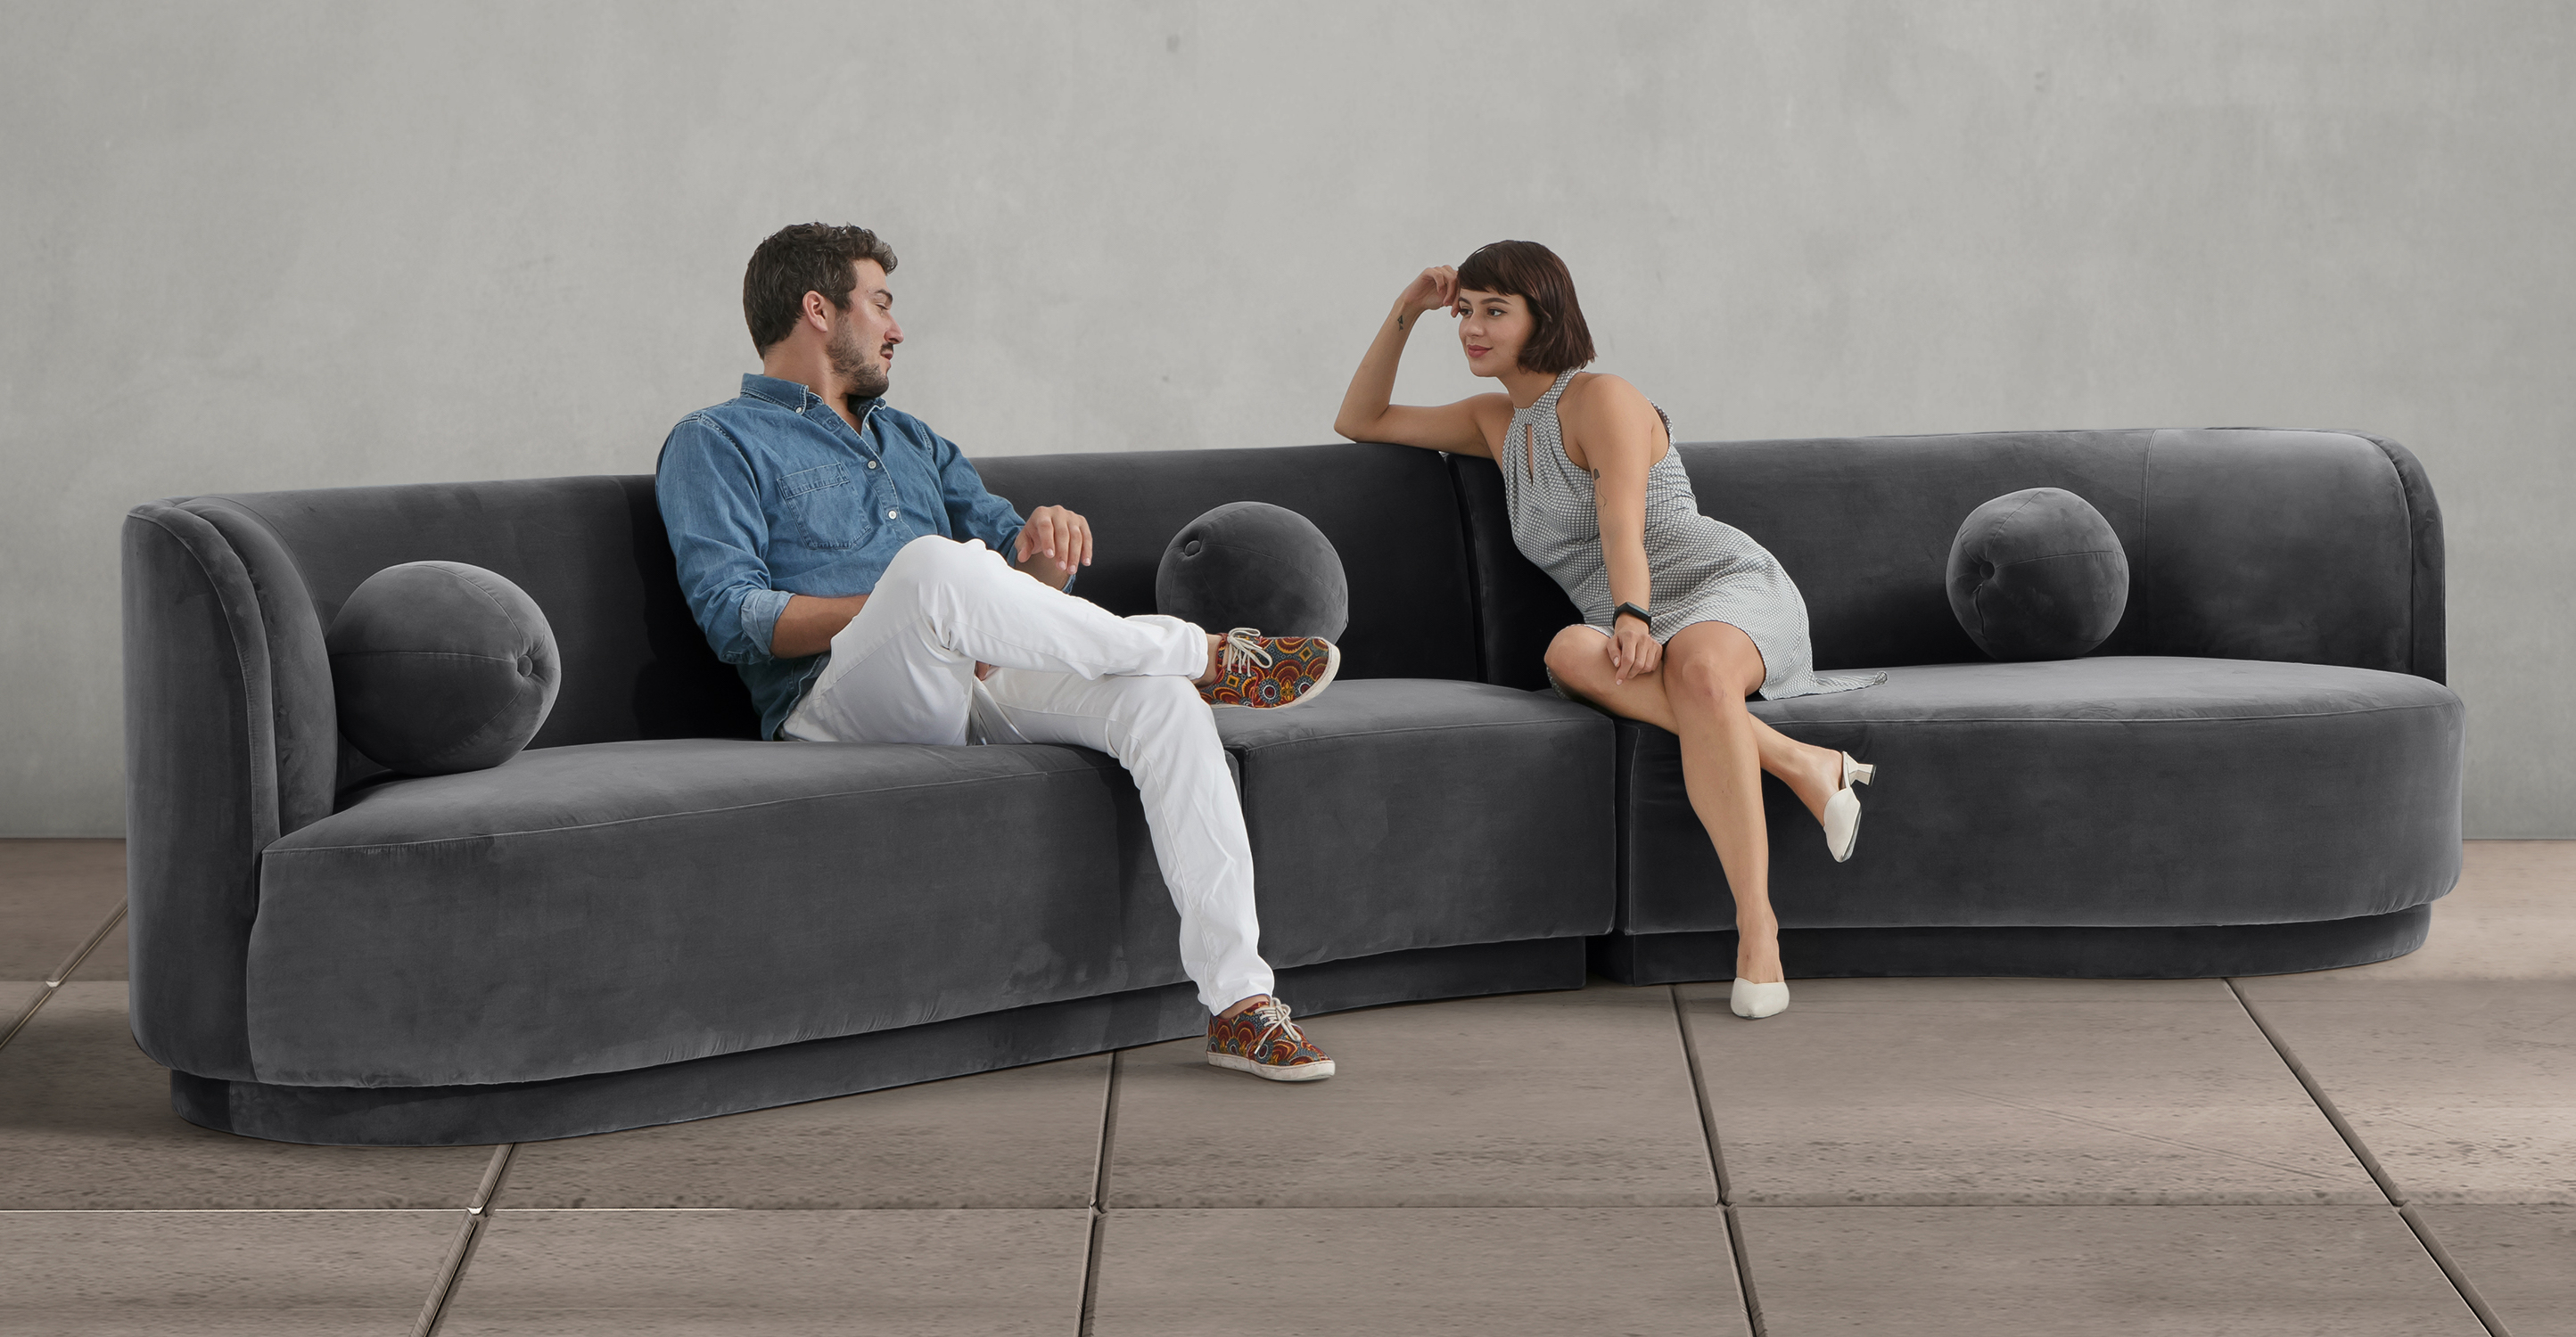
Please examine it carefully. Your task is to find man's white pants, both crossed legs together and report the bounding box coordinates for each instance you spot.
[780,536,1272,1013]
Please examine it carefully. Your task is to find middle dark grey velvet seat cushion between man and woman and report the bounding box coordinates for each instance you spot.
[1216,677,1615,966]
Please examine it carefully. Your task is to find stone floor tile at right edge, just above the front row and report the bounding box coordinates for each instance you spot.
[2239,973,2576,1203]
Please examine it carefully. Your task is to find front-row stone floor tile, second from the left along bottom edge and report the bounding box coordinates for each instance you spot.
[438,1208,1090,1337]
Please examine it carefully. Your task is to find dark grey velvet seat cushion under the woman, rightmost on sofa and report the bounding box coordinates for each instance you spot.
[1617,657,2463,932]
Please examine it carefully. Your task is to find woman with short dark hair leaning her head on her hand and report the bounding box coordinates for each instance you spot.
[1332,242,1886,1018]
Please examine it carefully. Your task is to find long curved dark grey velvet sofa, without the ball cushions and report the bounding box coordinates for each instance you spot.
[124,431,2463,1144]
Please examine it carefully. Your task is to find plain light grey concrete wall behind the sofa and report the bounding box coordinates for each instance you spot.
[14,0,2576,837]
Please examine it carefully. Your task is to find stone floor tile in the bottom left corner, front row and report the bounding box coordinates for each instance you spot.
[0,1210,464,1337]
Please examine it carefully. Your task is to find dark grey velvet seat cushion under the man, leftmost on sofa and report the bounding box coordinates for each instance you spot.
[247,739,1182,1085]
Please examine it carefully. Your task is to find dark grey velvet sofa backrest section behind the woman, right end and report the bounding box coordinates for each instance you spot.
[1453,428,2445,688]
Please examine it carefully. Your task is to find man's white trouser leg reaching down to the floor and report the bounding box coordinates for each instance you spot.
[984,660,1272,1013]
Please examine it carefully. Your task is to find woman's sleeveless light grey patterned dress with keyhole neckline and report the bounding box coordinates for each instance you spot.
[1497,371,1889,701]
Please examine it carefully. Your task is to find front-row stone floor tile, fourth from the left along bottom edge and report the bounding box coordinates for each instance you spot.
[1736,1210,2486,1337]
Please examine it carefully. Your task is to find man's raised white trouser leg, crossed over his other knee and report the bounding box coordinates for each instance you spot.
[780,536,1208,744]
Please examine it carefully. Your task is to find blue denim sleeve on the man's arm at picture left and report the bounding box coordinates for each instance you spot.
[654,414,788,665]
